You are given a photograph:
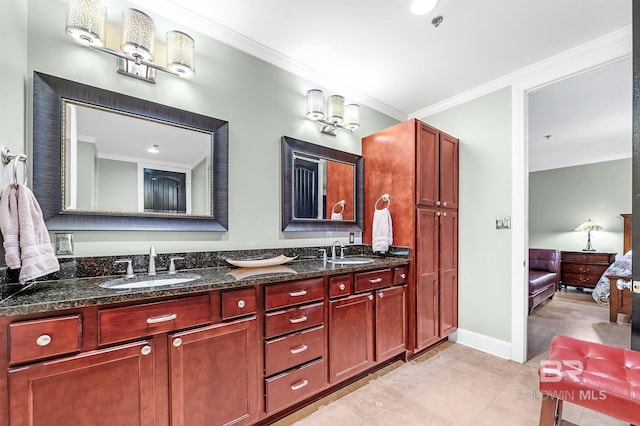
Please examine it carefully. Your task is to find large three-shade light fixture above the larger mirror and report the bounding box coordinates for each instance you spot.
[66,0,195,83]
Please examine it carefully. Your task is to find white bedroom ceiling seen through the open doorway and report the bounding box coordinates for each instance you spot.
[528,58,632,172]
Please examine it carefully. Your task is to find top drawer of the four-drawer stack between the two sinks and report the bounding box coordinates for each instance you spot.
[264,278,324,310]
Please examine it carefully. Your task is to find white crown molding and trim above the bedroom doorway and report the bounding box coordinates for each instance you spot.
[409,25,632,118]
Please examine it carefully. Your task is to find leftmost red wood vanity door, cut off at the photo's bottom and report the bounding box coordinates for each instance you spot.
[9,341,155,426]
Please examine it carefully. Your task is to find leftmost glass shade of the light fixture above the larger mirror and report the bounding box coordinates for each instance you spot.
[65,0,107,47]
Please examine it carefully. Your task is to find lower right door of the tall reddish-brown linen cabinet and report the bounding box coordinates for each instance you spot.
[438,211,458,337]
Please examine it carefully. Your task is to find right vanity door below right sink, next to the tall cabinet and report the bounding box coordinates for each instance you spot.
[375,286,407,362]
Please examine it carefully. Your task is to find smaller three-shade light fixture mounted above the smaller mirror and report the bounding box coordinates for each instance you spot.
[307,89,360,136]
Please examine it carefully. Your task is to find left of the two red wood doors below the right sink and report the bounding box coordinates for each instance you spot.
[329,293,374,383]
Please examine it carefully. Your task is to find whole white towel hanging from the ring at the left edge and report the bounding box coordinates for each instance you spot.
[0,184,60,284]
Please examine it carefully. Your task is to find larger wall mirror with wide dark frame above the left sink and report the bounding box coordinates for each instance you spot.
[33,72,228,231]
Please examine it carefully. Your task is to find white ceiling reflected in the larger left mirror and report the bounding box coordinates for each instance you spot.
[72,102,212,169]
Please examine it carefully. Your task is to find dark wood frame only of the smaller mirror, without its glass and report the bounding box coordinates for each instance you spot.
[281,136,364,232]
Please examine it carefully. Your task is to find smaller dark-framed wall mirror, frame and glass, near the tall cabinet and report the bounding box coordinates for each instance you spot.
[282,136,364,231]
